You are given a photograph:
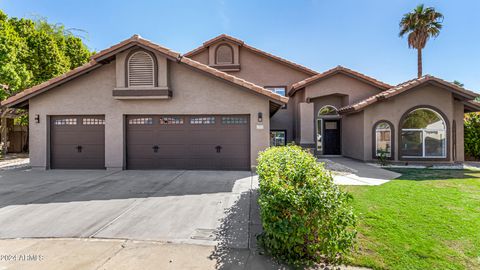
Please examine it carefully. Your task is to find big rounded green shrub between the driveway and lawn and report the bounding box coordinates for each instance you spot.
[257,146,356,265]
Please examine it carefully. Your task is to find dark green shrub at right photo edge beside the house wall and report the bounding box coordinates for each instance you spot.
[464,113,480,160]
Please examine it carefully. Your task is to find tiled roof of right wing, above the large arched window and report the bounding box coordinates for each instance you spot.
[338,75,479,113]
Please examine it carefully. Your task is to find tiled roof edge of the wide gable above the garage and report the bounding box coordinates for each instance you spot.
[1,35,288,107]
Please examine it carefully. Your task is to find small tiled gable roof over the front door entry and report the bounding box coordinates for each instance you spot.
[288,66,392,95]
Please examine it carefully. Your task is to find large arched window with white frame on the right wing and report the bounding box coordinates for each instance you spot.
[400,108,447,158]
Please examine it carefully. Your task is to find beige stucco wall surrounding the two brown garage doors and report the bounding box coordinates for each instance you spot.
[29,50,270,168]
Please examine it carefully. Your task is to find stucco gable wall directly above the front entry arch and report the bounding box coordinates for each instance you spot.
[304,74,381,106]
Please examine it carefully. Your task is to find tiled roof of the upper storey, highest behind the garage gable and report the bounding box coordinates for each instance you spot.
[184,34,318,75]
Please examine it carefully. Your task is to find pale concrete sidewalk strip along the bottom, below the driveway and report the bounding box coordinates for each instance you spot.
[0,238,372,270]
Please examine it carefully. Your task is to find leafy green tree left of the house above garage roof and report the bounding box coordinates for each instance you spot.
[0,10,92,100]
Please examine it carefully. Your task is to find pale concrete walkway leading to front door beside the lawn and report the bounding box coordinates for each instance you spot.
[318,157,401,186]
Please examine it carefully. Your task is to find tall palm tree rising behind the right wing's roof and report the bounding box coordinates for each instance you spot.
[399,4,443,78]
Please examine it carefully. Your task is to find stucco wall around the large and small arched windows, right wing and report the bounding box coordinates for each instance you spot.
[363,85,463,162]
